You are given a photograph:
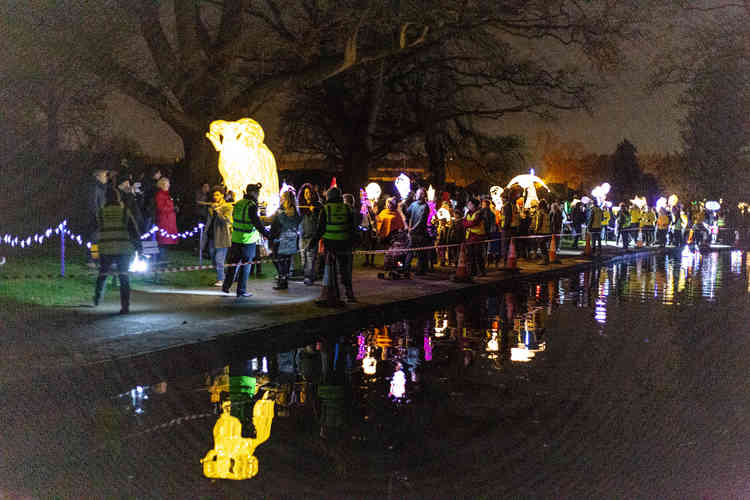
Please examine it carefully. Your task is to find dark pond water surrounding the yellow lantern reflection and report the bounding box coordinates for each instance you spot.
[0,251,750,498]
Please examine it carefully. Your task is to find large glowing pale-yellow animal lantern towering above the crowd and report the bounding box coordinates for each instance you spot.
[206,118,279,208]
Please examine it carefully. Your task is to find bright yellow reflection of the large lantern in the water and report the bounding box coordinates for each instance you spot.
[201,399,274,479]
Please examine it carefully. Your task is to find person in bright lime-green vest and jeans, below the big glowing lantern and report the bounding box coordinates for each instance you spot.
[221,183,270,297]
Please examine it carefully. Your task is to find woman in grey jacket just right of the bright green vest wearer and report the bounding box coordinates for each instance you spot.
[270,190,302,290]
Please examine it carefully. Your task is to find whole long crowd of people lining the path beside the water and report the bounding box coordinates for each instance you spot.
[85,164,736,313]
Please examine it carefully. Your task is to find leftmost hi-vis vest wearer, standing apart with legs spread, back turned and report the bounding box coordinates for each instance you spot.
[94,187,141,314]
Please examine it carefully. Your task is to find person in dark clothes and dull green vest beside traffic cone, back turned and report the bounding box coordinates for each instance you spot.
[315,186,357,305]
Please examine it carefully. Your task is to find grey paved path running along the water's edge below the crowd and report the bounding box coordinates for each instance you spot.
[0,248,648,382]
